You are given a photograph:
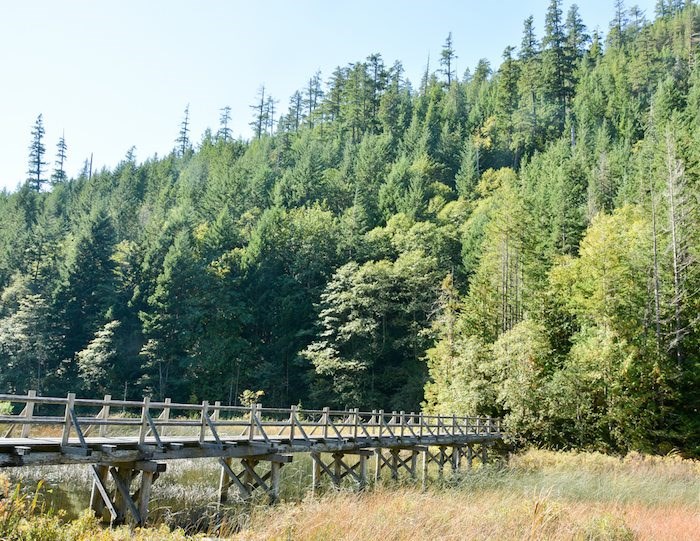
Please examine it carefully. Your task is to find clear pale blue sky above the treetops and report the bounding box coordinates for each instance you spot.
[0,0,655,190]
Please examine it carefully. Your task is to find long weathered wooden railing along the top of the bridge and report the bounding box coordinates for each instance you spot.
[0,391,501,447]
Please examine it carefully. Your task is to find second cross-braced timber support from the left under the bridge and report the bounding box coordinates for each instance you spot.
[219,454,292,504]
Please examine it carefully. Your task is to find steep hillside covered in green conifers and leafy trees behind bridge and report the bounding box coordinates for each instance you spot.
[0,0,700,454]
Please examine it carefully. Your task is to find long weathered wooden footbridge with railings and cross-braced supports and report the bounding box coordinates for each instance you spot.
[0,391,502,525]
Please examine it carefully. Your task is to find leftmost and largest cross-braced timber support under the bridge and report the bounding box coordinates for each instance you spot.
[90,461,166,526]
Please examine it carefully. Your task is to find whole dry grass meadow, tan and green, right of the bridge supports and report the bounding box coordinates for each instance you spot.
[234,451,700,541]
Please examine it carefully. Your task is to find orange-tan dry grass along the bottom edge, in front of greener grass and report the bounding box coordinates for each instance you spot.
[232,490,700,541]
